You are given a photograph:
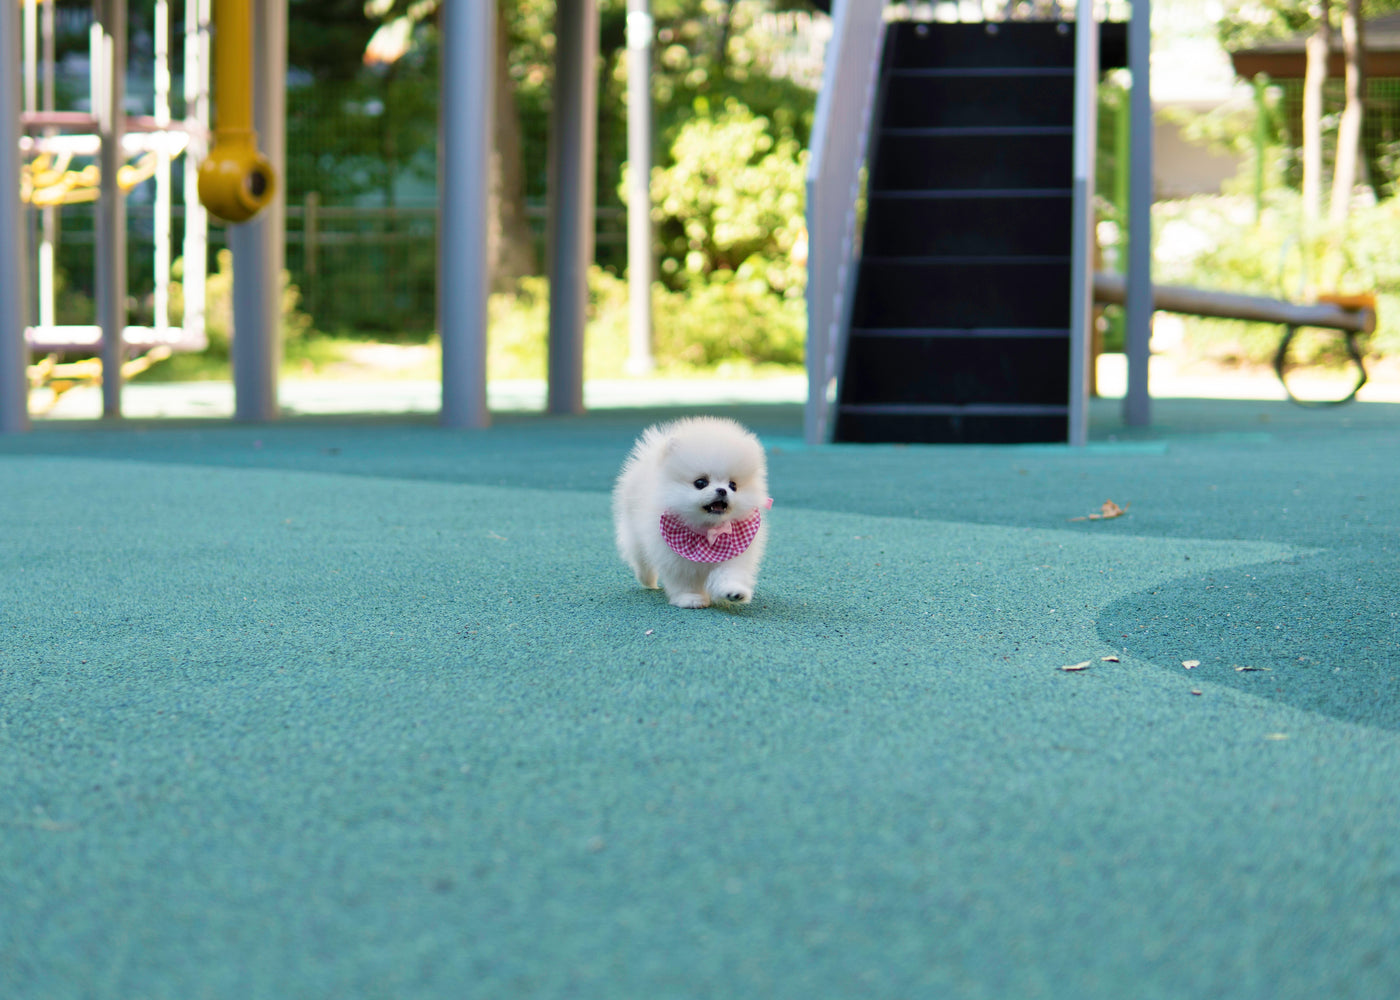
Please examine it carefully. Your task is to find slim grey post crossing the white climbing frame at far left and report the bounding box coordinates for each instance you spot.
[92,0,126,417]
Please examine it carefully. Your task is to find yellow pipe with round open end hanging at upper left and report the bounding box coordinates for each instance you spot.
[199,0,277,223]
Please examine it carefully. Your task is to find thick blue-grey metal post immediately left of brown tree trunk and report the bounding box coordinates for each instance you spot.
[437,0,496,427]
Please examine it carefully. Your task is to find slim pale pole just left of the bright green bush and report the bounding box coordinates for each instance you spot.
[627,0,655,375]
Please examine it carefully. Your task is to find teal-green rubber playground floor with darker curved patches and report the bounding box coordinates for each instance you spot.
[0,399,1400,1000]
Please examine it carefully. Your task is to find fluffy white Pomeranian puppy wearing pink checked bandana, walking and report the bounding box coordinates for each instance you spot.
[613,417,773,608]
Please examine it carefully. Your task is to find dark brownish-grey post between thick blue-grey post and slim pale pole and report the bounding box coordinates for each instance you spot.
[547,0,598,413]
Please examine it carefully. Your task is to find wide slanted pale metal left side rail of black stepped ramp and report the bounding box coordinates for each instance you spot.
[805,0,885,444]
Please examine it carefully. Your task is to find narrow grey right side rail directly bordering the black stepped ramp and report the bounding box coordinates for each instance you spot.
[1068,0,1099,444]
